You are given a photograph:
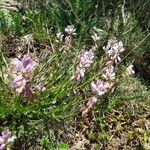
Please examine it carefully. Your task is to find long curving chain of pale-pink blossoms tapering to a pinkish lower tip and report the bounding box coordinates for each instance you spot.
[82,39,124,116]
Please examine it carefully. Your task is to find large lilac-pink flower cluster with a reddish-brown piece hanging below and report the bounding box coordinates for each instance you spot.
[12,55,36,100]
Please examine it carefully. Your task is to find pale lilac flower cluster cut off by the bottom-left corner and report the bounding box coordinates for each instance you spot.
[0,130,17,150]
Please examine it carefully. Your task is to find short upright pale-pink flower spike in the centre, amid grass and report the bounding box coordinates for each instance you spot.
[76,49,94,81]
